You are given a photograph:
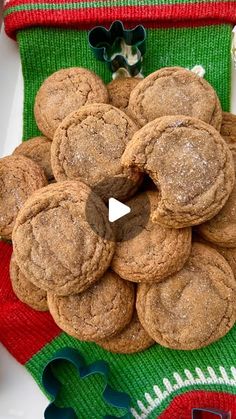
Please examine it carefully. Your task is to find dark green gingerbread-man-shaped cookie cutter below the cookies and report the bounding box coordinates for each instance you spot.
[42,348,131,419]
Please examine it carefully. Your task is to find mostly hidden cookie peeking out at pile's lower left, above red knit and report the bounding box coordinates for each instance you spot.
[10,254,48,311]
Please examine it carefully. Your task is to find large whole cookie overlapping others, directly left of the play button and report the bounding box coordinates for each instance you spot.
[13,181,114,295]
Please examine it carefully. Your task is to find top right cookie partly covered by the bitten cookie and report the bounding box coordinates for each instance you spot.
[128,67,222,130]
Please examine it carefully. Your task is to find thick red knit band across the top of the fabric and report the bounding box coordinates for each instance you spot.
[5,0,236,37]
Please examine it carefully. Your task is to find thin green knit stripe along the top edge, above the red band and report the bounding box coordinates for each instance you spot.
[4,0,232,17]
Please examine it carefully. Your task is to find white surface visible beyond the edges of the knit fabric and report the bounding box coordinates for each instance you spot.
[0,23,236,419]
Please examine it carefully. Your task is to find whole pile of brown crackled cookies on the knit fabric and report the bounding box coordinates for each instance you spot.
[0,67,236,353]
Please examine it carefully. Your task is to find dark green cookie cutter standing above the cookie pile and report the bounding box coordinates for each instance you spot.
[88,20,146,77]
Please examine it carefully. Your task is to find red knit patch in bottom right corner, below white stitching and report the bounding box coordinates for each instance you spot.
[158,391,236,419]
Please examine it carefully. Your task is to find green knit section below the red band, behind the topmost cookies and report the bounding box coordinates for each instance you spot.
[17,25,232,139]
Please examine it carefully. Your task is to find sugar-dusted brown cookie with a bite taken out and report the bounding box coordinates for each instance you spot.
[122,115,235,228]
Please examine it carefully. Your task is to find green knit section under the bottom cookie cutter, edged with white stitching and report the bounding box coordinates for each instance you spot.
[26,327,236,419]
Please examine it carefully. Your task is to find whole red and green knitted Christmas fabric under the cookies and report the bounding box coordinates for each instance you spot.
[0,0,236,419]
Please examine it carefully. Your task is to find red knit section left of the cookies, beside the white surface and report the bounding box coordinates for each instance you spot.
[0,242,61,364]
